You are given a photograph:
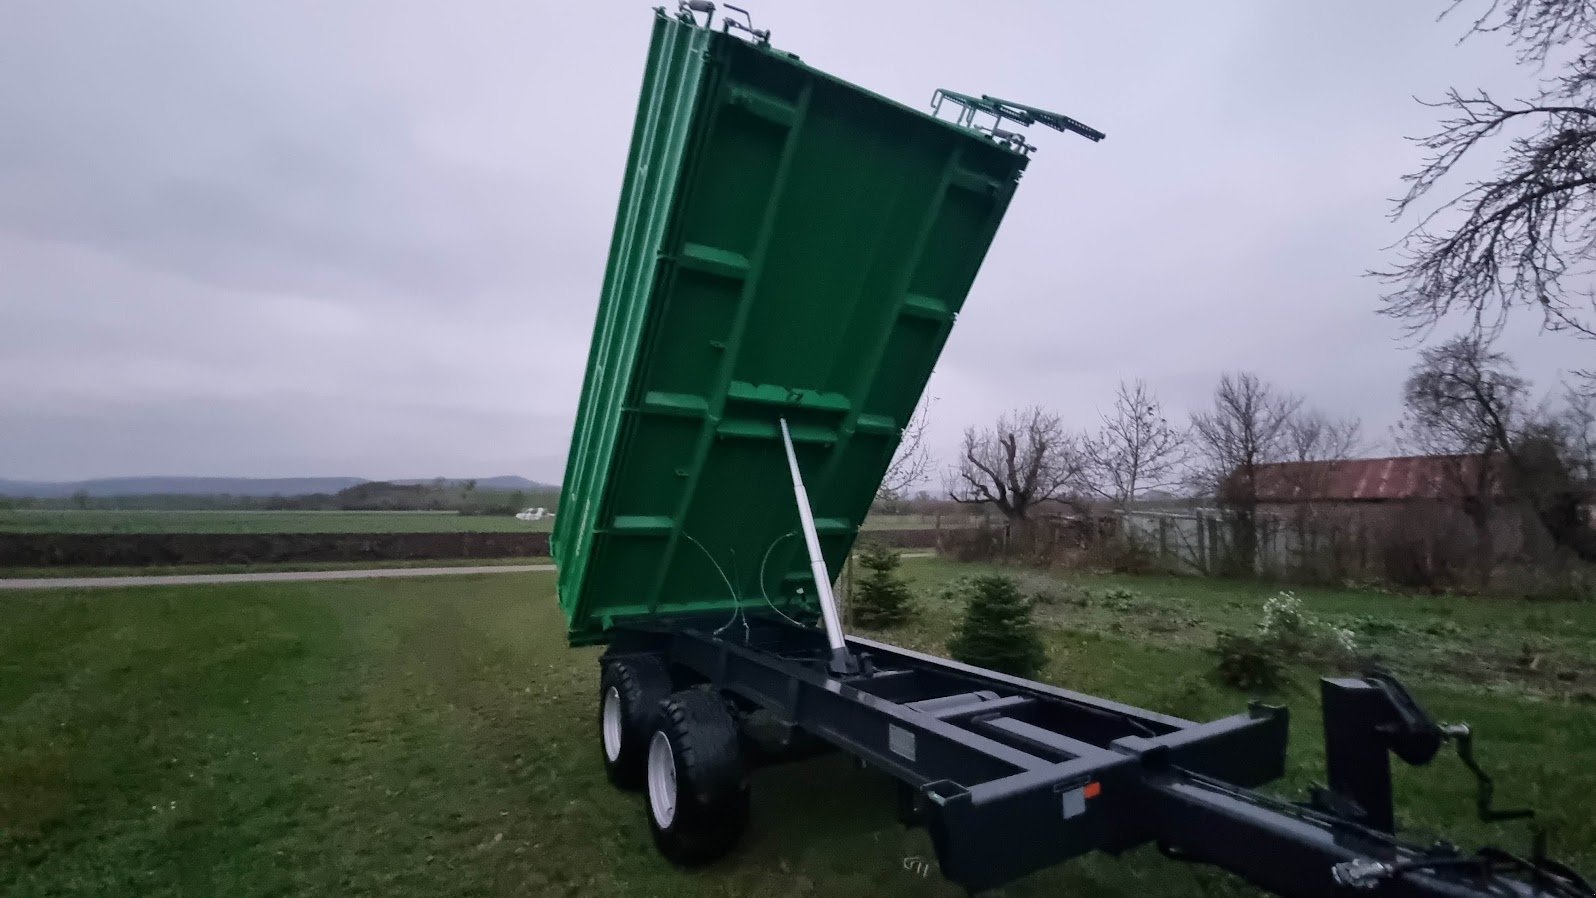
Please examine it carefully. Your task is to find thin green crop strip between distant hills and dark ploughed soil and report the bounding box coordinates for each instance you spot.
[0,509,554,533]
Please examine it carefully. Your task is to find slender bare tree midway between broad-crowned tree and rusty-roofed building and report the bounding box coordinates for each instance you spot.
[1082,380,1187,509]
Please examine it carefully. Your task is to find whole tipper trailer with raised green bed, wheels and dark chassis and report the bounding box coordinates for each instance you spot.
[554,8,1596,898]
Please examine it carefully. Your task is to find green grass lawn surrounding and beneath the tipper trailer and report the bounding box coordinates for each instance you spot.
[0,560,1596,896]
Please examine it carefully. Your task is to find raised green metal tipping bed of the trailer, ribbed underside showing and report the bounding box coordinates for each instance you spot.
[552,11,1026,644]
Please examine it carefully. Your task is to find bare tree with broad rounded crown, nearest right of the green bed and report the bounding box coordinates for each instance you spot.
[948,407,1085,523]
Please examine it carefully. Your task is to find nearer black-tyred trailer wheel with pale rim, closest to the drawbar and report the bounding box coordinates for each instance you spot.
[648,689,749,866]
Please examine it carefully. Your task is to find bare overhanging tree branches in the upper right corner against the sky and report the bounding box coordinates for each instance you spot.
[1374,0,1596,378]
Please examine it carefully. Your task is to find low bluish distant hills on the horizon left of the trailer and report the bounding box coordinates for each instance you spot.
[0,475,555,499]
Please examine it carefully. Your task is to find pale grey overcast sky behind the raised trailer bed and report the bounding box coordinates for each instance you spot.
[0,0,1593,482]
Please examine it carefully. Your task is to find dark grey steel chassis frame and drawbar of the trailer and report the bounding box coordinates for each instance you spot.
[606,616,1583,896]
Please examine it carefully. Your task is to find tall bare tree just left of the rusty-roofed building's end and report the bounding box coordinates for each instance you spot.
[1192,372,1302,573]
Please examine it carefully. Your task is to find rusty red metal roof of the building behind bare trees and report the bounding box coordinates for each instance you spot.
[1258,455,1502,502]
